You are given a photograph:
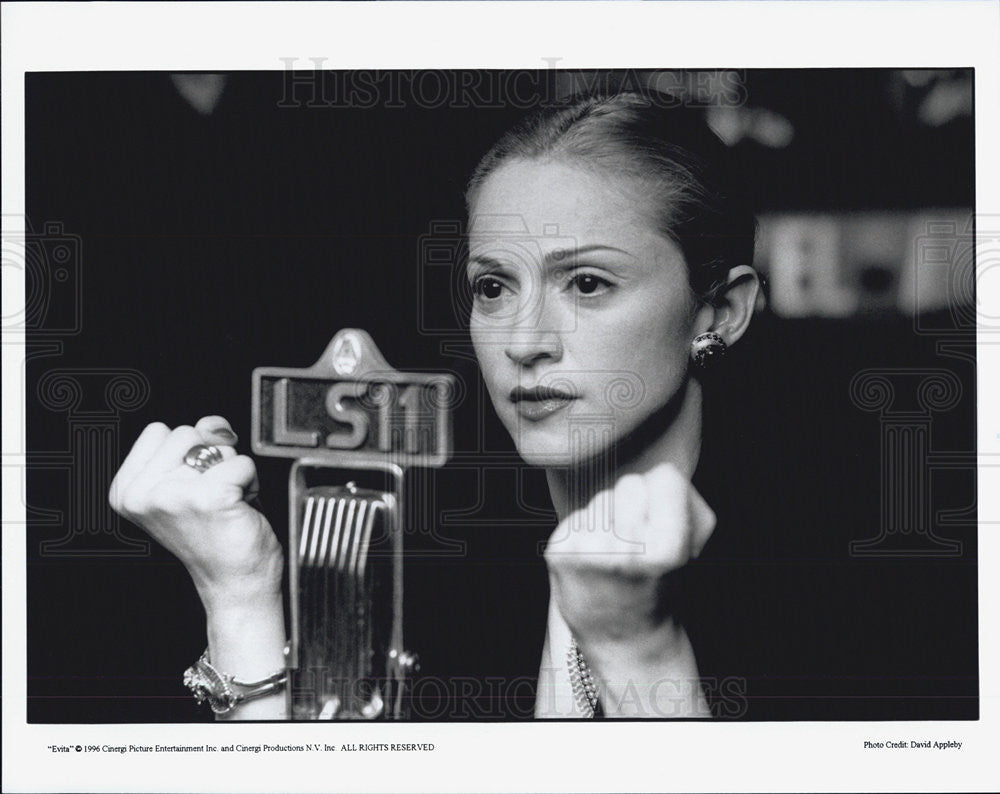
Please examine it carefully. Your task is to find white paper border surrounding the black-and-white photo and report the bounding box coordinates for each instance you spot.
[0,0,1000,791]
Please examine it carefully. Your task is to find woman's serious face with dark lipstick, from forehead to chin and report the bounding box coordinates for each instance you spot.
[468,160,695,466]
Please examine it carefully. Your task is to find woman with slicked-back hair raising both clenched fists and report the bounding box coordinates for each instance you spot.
[111,94,759,719]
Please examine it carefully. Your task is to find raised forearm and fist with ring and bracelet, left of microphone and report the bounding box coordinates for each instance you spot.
[108,416,287,719]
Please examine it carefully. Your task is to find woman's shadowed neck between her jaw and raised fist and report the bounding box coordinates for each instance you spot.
[545,378,702,521]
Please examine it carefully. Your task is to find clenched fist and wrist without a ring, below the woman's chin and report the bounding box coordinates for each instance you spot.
[545,464,715,716]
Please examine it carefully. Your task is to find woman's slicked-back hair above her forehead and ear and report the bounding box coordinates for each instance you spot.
[466,92,757,303]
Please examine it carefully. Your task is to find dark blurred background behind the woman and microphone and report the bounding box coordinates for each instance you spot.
[21,69,978,722]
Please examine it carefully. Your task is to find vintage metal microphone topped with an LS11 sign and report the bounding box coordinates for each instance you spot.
[252,329,456,720]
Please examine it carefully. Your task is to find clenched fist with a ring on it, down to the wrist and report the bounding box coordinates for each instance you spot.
[109,416,283,608]
